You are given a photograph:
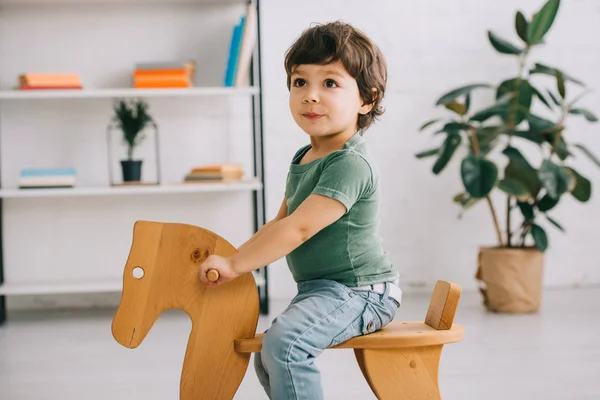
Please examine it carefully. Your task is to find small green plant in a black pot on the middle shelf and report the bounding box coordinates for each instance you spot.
[112,99,156,182]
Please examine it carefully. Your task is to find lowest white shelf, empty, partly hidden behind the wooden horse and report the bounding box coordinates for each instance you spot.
[0,273,264,296]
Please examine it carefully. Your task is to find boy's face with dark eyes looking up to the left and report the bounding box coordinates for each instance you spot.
[290,61,372,137]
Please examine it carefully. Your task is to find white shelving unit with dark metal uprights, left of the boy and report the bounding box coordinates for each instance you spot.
[0,0,268,324]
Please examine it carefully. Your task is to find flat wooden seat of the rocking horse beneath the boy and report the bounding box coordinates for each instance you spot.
[234,321,465,353]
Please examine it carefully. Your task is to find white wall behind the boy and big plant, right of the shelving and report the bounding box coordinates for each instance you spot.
[261,0,600,297]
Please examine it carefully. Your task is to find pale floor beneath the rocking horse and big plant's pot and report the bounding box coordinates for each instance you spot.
[0,288,600,400]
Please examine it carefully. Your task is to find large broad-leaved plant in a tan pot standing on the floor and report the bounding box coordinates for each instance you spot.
[416,0,600,313]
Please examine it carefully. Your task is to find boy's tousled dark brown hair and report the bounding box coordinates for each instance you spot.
[284,21,387,131]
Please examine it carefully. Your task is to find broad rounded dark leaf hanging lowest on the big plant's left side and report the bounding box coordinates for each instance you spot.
[461,155,498,198]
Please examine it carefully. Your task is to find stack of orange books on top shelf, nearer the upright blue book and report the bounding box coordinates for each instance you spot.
[133,60,196,89]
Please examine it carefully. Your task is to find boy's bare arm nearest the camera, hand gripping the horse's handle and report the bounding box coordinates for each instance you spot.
[199,194,346,285]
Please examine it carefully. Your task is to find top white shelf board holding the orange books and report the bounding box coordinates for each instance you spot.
[0,86,259,100]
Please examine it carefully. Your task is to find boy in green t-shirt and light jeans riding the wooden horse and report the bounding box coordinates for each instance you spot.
[199,22,402,400]
